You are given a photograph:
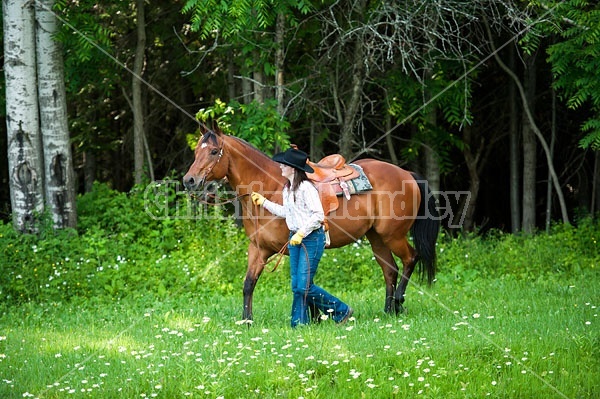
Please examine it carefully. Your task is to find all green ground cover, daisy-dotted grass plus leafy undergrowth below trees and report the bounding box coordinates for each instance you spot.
[0,185,600,399]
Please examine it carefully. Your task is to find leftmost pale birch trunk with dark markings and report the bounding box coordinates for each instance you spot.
[2,0,44,233]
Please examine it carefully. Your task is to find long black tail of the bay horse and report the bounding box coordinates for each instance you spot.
[411,173,440,285]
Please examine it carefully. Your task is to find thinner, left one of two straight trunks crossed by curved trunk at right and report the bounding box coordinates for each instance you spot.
[508,46,521,234]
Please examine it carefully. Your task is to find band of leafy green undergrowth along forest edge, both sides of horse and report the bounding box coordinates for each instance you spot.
[0,181,600,310]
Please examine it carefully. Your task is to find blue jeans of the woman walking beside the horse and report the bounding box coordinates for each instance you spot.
[288,228,349,327]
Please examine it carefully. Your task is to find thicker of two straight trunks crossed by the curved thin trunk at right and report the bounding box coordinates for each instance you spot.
[522,56,537,233]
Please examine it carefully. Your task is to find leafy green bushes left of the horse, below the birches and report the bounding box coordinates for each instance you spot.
[0,182,246,303]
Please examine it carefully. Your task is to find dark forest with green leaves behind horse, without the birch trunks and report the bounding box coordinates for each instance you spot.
[0,0,600,232]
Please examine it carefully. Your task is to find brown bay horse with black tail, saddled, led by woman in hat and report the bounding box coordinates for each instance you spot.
[183,128,440,321]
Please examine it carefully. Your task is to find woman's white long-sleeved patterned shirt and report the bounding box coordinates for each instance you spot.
[263,180,325,237]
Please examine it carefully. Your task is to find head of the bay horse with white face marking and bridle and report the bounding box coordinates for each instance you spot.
[183,130,227,191]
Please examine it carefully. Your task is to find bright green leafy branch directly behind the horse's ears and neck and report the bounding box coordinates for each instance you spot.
[197,99,290,154]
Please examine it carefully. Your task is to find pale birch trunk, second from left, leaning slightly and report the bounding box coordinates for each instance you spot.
[35,0,77,228]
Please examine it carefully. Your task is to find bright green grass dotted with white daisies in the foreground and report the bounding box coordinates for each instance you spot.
[0,265,600,399]
